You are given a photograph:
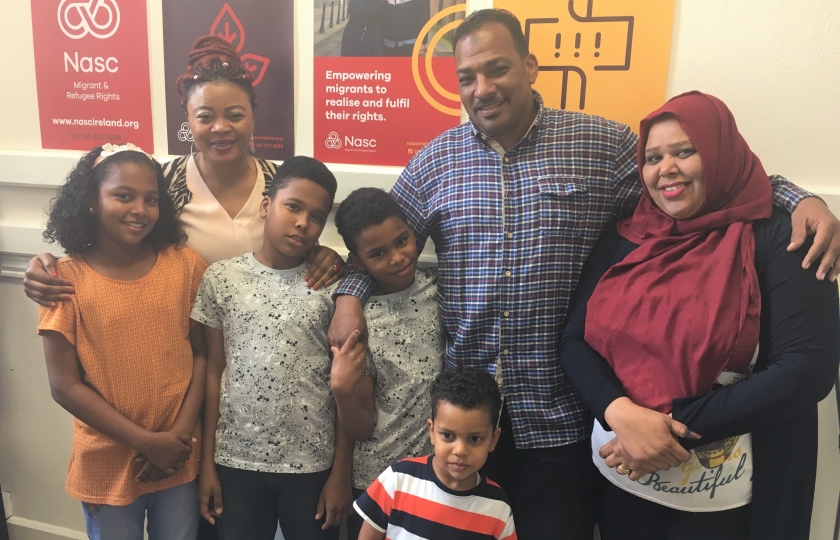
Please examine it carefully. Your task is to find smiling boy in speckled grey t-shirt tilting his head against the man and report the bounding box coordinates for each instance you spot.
[331,188,444,540]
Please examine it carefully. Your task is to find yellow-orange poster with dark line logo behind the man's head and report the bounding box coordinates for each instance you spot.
[494,0,674,131]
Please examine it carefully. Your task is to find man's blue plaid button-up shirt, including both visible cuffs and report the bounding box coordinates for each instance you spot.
[335,92,810,448]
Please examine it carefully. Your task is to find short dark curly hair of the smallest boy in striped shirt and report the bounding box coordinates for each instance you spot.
[430,367,502,427]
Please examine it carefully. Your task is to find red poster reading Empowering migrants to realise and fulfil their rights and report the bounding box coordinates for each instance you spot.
[314,0,466,166]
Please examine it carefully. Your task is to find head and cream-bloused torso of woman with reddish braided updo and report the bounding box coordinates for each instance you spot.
[164,36,270,264]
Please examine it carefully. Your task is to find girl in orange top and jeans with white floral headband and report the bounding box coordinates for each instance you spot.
[38,145,207,540]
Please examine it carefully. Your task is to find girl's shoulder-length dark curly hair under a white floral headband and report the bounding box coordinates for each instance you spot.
[44,147,187,255]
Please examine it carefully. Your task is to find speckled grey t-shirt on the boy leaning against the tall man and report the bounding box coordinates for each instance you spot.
[353,268,444,489]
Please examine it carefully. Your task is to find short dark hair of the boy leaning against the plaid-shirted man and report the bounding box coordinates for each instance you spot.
[335,188,408,253]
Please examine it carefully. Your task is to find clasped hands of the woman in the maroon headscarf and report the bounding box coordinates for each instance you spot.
[598,397,700,480]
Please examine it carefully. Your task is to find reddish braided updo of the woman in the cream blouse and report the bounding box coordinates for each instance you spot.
[175,34,257,110]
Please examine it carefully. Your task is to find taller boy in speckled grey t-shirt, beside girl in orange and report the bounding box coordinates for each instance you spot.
[192,157,346,540]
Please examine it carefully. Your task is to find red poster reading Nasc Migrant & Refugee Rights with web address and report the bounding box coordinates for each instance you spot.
[32,0,154,152]
